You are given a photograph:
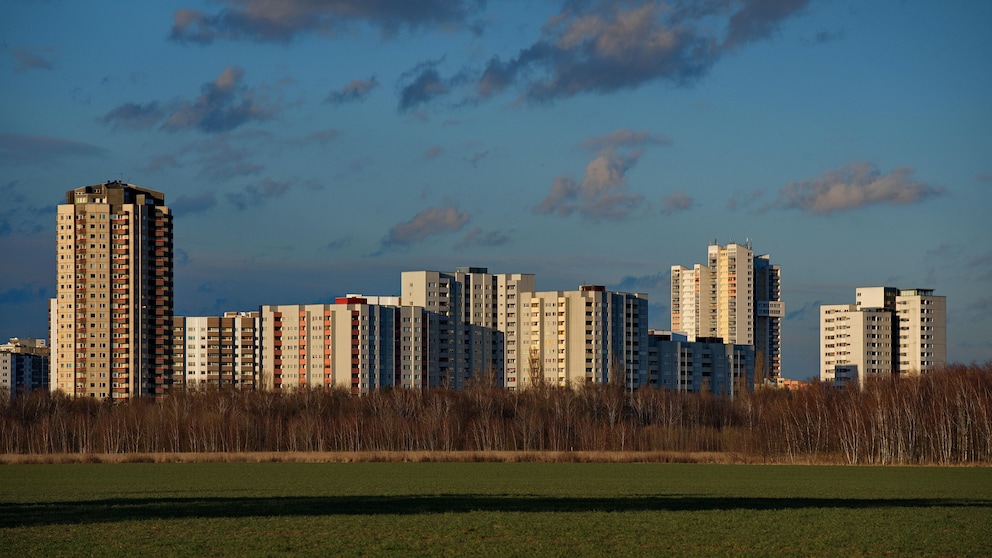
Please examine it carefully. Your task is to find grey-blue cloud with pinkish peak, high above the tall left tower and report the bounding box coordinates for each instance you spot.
[100,66,278,134]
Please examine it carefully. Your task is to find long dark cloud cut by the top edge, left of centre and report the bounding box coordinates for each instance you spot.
[170,0,484,44]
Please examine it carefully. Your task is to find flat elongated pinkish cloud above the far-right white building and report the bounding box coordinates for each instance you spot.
[769,163,945,215]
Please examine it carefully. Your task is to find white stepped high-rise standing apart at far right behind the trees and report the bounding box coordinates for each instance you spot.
[820,287,947,385]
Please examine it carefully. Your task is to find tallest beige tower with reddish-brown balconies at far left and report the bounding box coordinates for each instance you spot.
[50,181,173,400]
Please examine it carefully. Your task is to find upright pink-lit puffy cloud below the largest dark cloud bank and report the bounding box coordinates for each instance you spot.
[534,128,669,223]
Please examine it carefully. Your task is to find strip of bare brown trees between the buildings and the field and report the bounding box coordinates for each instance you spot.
[0,362,992,464]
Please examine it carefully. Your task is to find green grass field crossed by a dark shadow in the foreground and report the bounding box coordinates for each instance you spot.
[0,463,992,556]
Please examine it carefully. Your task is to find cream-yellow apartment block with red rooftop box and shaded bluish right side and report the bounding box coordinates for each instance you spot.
[520,285,648,389]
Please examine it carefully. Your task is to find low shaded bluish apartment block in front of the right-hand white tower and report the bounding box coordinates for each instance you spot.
[648,331,755,397]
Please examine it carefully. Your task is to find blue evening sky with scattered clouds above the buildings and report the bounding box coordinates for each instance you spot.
[0,0,992,379]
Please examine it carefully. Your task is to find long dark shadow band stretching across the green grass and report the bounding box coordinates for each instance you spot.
[0,494,992,527]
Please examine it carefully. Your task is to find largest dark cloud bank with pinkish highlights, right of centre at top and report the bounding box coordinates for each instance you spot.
[474,0,808,103]
